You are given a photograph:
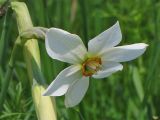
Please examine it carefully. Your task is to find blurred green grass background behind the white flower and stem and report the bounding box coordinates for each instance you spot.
[0,0,160,120]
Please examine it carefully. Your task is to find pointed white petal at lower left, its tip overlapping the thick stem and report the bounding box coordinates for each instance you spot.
[43,65,82,96]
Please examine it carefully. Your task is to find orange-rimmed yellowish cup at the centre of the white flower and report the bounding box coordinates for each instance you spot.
[82,57,102,76]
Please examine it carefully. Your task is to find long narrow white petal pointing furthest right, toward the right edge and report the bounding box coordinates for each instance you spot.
[102,43,148,62]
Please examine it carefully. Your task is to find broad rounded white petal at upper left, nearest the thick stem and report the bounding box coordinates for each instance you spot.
[45,28,87,63]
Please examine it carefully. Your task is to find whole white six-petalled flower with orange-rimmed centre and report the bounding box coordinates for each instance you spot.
[43,22,147,107]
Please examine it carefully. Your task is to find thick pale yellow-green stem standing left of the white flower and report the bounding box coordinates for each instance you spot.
[11,2,56,120]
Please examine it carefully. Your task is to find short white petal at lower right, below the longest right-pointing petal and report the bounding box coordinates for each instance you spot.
[92,61,123,78]
